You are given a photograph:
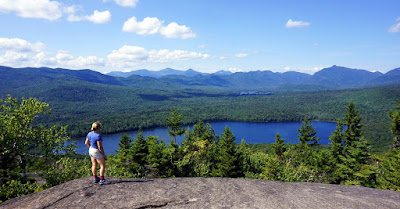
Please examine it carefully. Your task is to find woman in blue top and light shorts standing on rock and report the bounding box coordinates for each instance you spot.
[85,122,110,184]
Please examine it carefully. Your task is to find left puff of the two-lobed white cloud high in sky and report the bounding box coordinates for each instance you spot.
[122,17,164,35]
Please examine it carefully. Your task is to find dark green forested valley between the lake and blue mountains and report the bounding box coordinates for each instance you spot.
[11,83,400,152]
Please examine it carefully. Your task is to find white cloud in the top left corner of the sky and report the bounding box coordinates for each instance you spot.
[0,0,62,20]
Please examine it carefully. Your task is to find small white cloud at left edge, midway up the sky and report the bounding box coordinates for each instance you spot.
[0,38,44,52]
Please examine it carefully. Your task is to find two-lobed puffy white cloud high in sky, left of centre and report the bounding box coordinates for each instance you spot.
[122,17,196,39]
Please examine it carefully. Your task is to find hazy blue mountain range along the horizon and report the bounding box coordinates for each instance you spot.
[0,65,400,93]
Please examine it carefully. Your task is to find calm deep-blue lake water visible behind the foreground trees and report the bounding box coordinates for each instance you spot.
[68,121,336,155]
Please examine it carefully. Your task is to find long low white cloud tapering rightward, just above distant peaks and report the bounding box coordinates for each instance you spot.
[107,45,210,67]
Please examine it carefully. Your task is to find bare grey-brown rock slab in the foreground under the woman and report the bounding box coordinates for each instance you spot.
[0,177,400,209]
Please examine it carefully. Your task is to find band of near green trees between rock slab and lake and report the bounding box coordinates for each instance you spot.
[0,96,400,204]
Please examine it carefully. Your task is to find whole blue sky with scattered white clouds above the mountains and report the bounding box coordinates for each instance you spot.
[0,0,400,74]
